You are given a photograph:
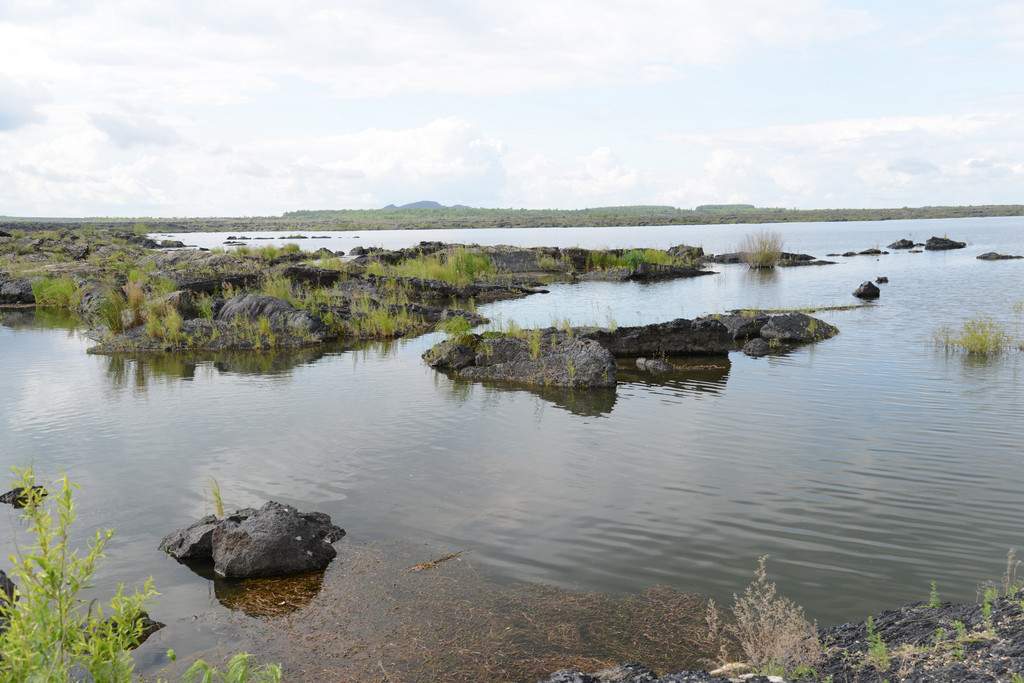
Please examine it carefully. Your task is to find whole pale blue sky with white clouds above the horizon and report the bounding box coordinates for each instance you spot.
[0,0,1024,216]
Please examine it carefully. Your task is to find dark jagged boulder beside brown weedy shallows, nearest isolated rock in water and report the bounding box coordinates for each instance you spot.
[160,501,345,578]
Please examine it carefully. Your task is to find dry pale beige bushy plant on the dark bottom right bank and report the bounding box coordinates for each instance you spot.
[726,555,821,672]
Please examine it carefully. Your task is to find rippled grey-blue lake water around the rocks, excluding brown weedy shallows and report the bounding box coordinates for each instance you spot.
[0,217,1024,671]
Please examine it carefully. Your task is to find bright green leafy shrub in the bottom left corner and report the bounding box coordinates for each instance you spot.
[0,466,282,683]
